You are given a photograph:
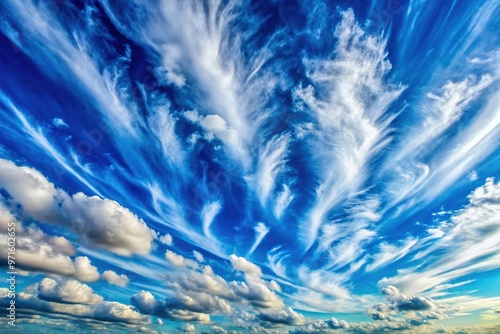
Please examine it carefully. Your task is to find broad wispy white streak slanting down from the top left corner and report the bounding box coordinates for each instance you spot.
[0,0,140,135]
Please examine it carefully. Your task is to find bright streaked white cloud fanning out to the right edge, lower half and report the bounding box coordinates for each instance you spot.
[379,178,500,296]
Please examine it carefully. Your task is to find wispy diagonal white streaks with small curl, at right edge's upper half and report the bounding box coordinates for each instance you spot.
[383,75,500,214]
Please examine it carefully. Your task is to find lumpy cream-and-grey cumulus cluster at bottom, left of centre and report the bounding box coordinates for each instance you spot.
[131,251,294,325]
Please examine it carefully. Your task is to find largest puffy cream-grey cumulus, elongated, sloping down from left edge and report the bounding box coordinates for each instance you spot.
[0,159,155,256]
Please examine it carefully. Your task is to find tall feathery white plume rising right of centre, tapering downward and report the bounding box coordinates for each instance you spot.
[293,10,403,249]
